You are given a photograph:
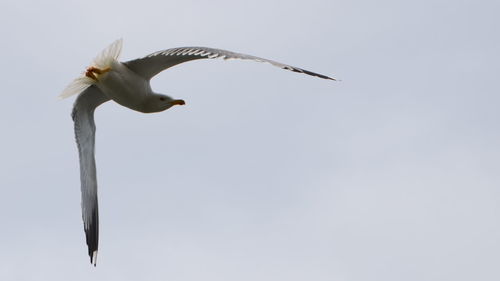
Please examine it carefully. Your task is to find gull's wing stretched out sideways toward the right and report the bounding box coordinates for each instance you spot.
[125,47,336,80]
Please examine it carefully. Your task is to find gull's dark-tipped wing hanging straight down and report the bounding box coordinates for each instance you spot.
[71,85,109,266]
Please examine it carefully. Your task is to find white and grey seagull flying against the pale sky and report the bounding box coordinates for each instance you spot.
[60,39,336,266]
